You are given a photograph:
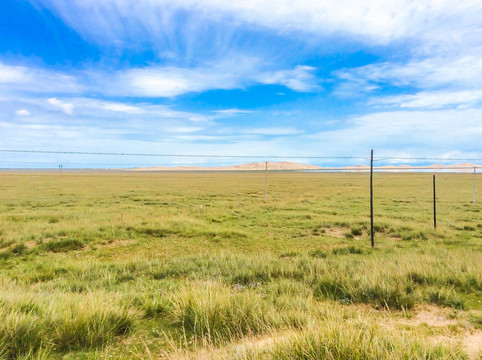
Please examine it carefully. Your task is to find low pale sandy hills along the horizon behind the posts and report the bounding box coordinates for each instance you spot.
[127,161,482,171]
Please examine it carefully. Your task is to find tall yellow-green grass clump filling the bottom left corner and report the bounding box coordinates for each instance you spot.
[0,287,135,359]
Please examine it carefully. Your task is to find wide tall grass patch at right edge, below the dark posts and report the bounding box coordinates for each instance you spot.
[311,250,482,309]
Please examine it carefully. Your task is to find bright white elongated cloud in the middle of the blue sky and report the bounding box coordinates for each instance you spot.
[100,56,319,97]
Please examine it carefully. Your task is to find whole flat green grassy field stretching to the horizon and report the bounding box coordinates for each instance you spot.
[0,172,482,359]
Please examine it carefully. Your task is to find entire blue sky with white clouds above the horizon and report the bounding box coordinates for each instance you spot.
[0,0,482,168]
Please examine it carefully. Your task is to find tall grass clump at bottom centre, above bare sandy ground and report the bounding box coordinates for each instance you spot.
[169,282,305,344]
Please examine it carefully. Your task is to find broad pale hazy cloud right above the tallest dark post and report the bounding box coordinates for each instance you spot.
[310,109,482,157]
